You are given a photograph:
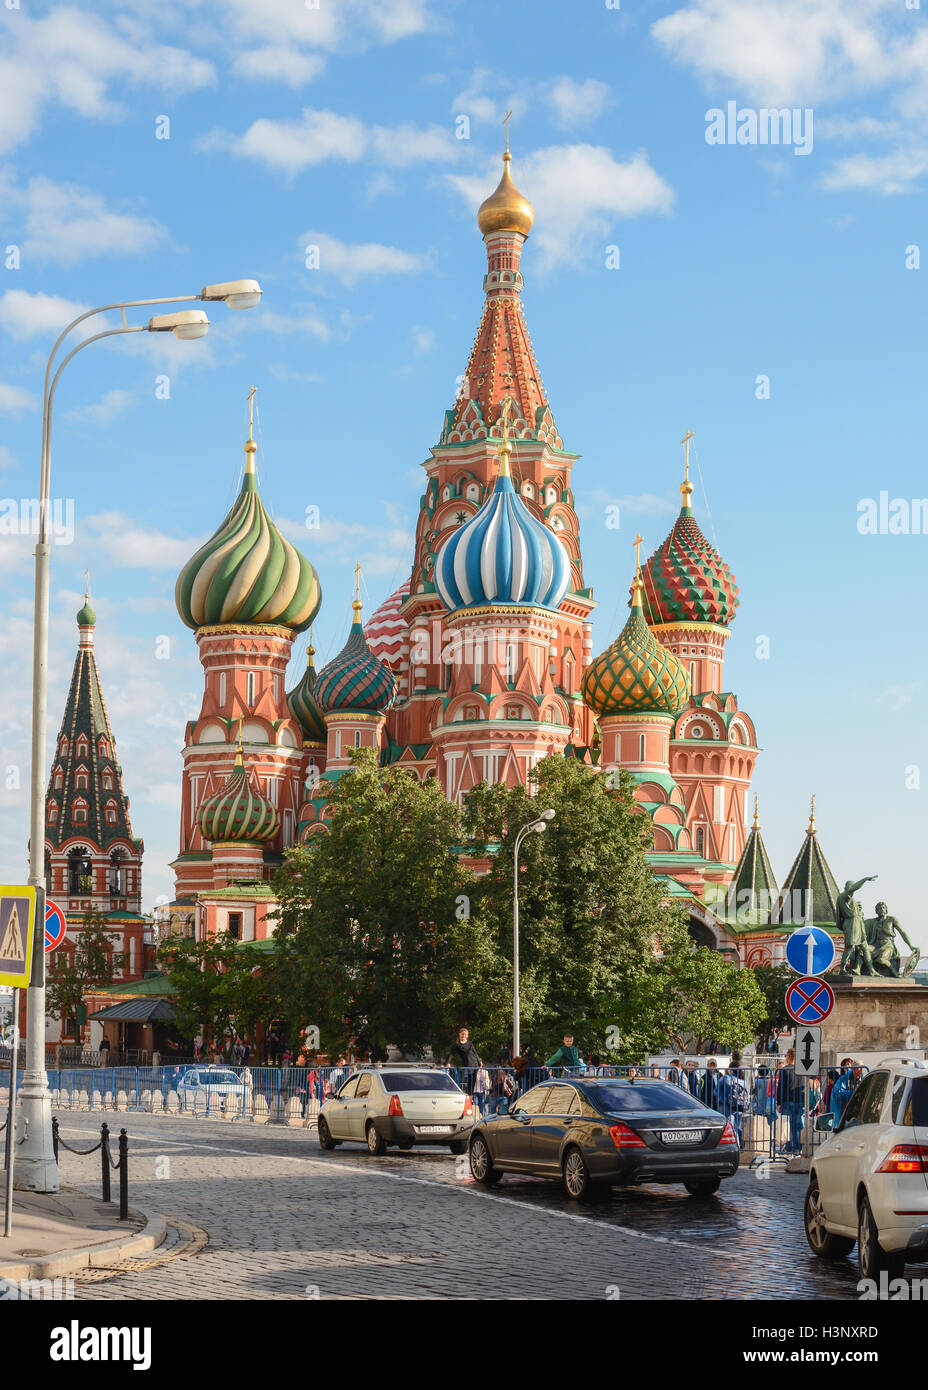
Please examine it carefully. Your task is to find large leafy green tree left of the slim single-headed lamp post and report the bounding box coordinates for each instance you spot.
[268,751,474,1056]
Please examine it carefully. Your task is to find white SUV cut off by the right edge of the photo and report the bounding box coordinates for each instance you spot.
[804,1062,928,1279]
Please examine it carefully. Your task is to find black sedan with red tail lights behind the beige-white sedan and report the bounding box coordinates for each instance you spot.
[470,1077,739,1201]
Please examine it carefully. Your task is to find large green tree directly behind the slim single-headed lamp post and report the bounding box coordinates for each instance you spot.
[457,758,679,1059]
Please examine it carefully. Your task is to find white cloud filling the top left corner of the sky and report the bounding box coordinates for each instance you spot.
[0,7,215,153]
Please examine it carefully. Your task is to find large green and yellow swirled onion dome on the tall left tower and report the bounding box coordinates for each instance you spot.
[174,441,322,632]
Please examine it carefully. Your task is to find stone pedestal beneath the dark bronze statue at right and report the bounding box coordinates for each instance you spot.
[821,976,928,1050]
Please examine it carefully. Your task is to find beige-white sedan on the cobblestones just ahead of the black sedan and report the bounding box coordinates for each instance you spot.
[320,1063,474,1154]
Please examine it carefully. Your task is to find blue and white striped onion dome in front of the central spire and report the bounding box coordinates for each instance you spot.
[435,441,571,612]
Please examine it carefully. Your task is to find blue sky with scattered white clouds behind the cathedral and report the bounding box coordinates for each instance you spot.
[0,0,928,948]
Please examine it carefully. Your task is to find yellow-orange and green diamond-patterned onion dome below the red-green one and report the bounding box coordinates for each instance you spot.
[583,577,689,717]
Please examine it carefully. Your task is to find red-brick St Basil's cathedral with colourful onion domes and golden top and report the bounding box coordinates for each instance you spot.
[47,147,838,1034]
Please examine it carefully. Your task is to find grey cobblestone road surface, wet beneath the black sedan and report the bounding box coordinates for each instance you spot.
[58,1112,857,1300]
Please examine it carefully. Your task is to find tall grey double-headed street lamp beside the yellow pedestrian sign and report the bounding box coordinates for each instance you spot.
[15,279,261,1193]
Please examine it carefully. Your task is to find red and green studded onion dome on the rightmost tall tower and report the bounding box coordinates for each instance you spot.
[643,467,738,627]
